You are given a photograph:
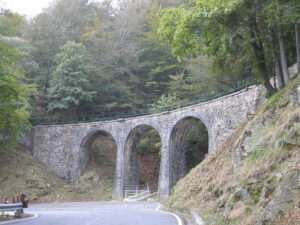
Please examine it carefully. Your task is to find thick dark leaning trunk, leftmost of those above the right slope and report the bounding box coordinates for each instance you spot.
[250,19,276,95]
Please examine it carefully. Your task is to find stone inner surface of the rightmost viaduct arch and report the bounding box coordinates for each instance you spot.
[169,116,211,188]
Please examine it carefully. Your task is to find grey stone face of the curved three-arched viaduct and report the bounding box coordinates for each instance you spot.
[33,86,265,198]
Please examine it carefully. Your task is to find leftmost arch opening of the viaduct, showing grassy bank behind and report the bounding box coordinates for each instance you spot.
[78,130,117,200]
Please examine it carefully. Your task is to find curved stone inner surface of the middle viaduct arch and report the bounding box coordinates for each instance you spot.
[123,124,162,190]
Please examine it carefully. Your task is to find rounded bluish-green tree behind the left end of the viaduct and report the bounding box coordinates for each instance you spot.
[48,42,96,118]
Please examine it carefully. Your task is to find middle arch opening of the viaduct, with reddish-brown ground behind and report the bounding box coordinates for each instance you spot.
[124,125,161,190]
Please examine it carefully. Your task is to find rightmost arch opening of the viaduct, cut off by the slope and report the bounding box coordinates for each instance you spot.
[170,117,209,188]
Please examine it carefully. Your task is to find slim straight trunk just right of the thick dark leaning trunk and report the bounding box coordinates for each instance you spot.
[270,29,284,90]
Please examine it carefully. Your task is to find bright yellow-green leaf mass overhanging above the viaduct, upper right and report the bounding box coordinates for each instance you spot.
[158,0,243,56]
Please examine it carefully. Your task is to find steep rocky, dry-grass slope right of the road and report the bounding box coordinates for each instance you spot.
[166,75,300,225]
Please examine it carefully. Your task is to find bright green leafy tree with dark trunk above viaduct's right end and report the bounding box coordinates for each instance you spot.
[159,0,298,94]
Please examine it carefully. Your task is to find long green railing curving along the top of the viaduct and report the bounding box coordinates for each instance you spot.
[30,78,256,126]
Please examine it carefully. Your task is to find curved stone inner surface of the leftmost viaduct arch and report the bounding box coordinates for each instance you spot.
[77,128,118,181]
